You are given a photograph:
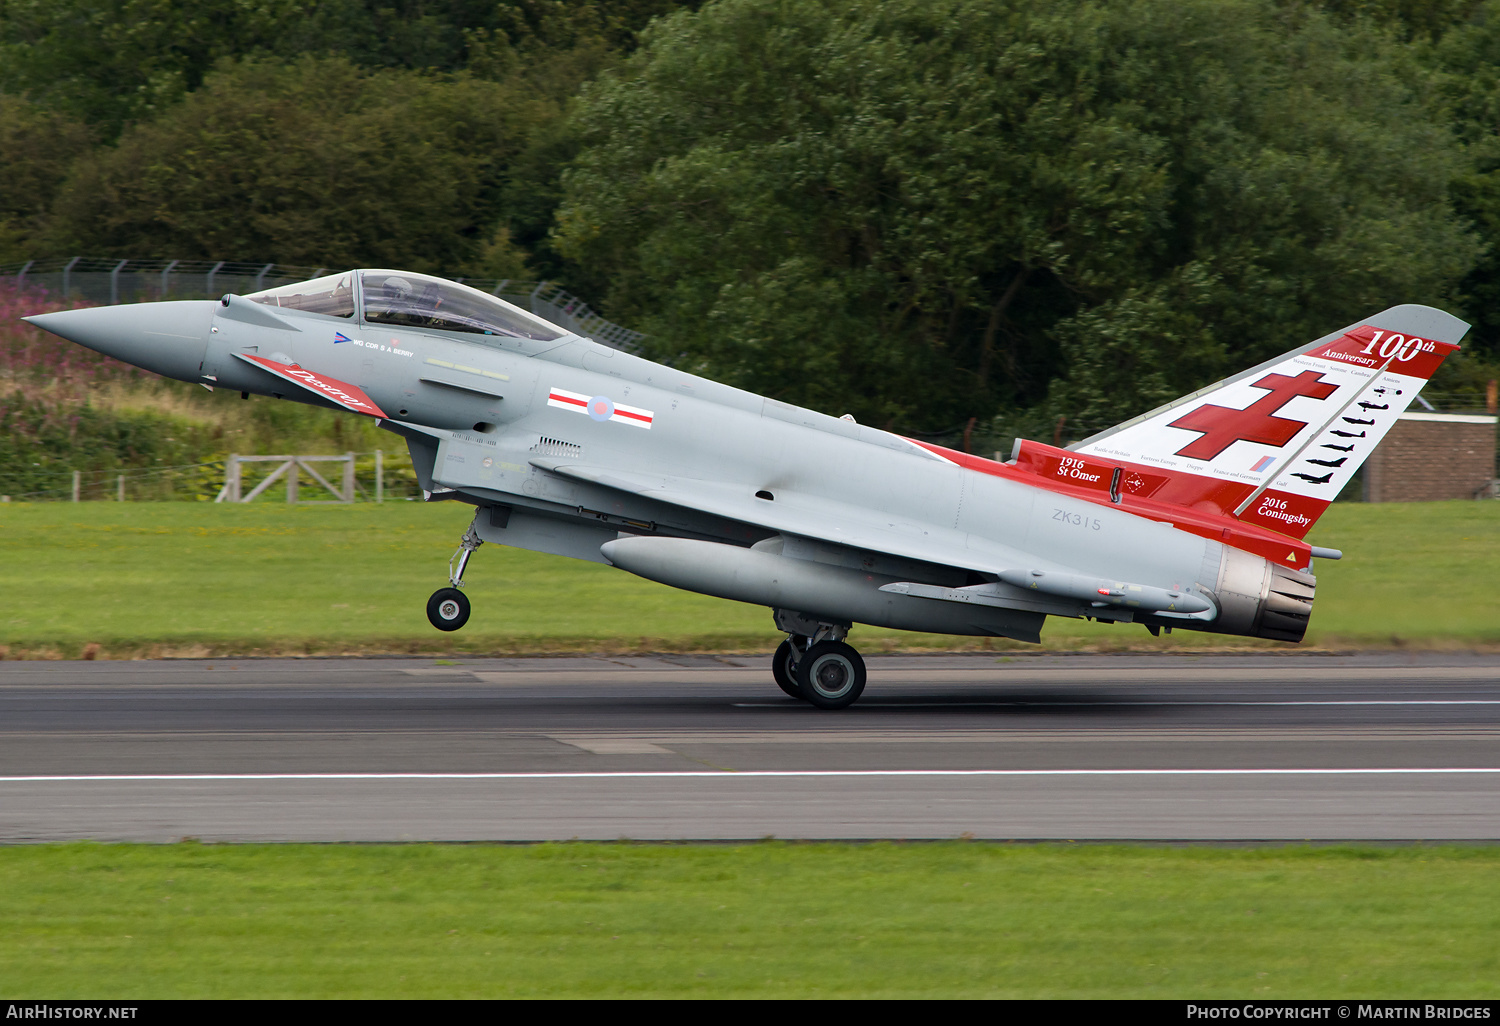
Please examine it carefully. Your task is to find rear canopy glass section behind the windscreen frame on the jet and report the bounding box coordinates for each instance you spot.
[360,272,567,342]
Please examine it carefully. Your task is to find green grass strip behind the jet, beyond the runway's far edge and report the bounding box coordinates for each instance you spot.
[0,503,1500,659]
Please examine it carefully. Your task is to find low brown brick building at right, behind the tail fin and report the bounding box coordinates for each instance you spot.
[1365,413,1497,503]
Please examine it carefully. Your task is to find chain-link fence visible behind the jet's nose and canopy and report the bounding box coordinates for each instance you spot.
[0,257,644,351]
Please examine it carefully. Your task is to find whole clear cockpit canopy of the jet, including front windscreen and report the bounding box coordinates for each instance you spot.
[246,270,567,342]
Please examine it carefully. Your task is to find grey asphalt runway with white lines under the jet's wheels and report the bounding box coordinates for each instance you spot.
[0,654,1500,843]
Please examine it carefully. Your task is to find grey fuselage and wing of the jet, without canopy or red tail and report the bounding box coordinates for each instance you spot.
[23,285,1311,642]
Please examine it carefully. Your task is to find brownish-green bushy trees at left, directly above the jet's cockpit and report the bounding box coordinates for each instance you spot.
[54,57,552,270]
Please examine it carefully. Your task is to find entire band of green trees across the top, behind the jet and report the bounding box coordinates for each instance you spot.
[0,0,1500,444]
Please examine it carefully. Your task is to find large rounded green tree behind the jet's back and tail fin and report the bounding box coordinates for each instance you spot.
[560,0,1478,431]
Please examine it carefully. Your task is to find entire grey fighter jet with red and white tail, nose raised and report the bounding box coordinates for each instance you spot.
[27,270,1469,708]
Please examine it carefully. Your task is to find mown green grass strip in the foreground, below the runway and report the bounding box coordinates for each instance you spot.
[0,842,1500,999]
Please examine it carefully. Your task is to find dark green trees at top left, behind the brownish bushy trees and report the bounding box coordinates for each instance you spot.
[0,0,680,138]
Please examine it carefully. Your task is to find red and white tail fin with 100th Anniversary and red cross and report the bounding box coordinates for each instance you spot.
[1070,305,1469,539]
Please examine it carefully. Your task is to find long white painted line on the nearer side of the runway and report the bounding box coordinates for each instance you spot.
[0,767,1500,783]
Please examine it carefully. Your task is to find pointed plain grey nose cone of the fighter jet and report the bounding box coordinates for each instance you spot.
[23,300,216,381]
